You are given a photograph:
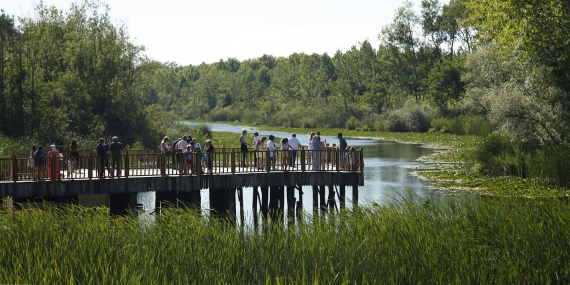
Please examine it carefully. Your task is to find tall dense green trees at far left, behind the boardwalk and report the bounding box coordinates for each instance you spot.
[0,1,160,146]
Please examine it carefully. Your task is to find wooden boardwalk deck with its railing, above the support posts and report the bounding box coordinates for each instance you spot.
[0,148,364,198]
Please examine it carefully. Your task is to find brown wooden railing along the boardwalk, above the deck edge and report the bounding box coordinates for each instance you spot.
[0,147,364,182]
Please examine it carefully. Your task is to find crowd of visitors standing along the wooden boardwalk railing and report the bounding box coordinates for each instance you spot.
[28,130,357,180]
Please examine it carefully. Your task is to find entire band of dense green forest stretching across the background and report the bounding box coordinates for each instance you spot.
[0,0,570,146]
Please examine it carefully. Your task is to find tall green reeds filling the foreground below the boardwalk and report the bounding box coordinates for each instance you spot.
[0,197,570,284]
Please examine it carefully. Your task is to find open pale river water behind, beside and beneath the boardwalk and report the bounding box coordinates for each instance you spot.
[166,123,435,220]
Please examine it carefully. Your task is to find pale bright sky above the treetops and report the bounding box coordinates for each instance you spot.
[0,0,421,65]
